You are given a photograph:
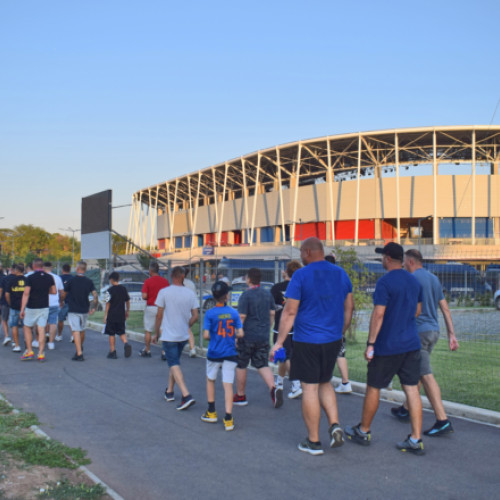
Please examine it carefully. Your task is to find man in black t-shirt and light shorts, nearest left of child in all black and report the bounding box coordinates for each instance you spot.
[65,260,98,361]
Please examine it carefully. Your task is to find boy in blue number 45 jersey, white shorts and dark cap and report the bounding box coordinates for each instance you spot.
[201,281,243,431]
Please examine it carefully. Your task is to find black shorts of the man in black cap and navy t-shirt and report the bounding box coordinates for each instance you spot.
[366,350,420,389]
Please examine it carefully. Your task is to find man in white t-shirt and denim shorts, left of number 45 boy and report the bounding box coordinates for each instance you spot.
[155,266,200,410]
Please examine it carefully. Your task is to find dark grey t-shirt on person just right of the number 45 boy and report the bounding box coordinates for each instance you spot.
[238,287,276,342]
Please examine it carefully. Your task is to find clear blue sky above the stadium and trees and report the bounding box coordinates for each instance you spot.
[0,0,500,240]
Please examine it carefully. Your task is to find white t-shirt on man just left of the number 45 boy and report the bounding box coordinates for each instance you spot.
[155,285,200,342]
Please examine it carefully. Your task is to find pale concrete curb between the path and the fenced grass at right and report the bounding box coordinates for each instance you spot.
[88,321,500,427]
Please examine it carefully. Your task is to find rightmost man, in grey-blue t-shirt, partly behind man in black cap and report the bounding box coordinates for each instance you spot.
[391,249,458,437]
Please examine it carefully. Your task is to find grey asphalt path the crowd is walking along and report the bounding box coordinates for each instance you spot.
[0,328,500,500]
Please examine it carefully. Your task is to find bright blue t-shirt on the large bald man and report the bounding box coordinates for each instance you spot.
[285,260,352,344]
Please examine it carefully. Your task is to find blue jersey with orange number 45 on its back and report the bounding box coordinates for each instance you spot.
[203,305,242,361]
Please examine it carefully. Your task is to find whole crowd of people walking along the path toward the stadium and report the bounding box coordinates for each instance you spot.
[0,238,458,455]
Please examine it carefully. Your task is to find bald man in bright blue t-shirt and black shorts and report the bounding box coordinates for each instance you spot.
[272,238,354,455]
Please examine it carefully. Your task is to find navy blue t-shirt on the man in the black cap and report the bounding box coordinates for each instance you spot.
[373,269,422,356]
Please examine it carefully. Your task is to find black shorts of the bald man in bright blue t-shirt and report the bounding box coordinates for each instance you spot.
[290,339,342,384]
